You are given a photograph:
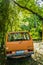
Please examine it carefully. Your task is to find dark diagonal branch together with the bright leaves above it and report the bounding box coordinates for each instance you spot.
[13,0,43,20]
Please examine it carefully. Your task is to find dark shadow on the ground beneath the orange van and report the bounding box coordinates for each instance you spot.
[6,57,38,65]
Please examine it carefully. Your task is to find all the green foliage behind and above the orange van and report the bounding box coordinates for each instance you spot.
[0,0,43,44]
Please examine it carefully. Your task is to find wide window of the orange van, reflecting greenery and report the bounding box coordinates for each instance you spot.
[8,32,30,41]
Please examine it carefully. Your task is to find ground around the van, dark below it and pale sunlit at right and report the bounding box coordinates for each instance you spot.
[0,42,43,65]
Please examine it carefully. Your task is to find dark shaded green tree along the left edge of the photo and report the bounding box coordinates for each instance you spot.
[0,0,9,65]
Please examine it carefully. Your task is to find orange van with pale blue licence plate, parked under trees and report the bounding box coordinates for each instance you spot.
[5,32,34,58]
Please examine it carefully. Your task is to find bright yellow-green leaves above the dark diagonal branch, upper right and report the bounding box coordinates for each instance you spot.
[16,0,43,17]
